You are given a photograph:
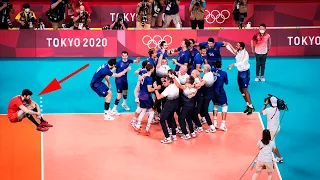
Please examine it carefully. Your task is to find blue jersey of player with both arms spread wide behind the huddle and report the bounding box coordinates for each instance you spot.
[199,42,223,66]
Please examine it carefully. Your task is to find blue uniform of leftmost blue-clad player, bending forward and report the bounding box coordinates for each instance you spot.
[90,64,113,97]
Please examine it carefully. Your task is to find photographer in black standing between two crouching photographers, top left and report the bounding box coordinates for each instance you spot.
[46,0,69,30]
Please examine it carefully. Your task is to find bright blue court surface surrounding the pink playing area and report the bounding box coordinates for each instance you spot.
[0,57,320,180]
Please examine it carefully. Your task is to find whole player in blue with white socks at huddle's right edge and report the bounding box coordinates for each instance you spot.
[212,60,229,131]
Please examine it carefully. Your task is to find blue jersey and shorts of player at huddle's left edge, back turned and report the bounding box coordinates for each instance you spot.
[138,76,153,109]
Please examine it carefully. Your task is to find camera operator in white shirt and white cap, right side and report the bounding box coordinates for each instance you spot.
[261,96,283,163]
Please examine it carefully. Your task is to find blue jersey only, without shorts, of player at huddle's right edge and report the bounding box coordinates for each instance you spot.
[211,68,229,94]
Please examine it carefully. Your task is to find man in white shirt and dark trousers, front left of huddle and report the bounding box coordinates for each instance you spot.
[153,76,180,144]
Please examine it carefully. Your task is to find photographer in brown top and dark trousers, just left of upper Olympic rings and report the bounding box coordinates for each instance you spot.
[189,0,207,29]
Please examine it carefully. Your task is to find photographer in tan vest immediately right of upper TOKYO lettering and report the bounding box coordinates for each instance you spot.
[136,0,152,30]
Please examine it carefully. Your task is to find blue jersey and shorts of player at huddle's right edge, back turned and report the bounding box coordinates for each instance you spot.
[211,68,229,106]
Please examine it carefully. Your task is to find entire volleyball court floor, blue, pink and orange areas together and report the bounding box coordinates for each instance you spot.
[0,57,320,180]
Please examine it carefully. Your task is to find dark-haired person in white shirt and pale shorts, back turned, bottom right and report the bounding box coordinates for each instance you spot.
[252,129,277,180]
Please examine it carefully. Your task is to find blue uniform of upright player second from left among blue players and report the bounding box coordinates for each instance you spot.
[115,59,134,93]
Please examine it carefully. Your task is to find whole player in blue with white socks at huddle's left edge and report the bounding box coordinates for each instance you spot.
[135,64,155,134]
